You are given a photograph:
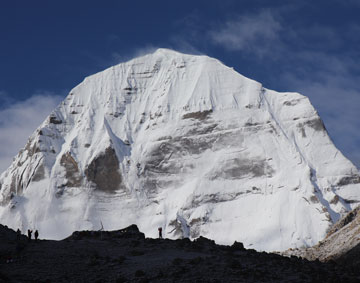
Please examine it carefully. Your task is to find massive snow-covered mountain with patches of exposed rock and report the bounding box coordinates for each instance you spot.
[0,49,360,250]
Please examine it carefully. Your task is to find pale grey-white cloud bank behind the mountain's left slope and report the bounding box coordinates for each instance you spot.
[0,92,63,173]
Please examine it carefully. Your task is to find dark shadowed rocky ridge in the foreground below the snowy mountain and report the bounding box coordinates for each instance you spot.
[0,225,360,282]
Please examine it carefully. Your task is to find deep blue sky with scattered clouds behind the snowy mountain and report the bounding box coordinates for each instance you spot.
[0,0,360,171]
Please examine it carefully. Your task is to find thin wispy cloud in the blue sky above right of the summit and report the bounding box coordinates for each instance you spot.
[209,10,282,56]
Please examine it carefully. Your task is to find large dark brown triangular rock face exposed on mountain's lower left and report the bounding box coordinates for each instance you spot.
[85,147,123,192]
